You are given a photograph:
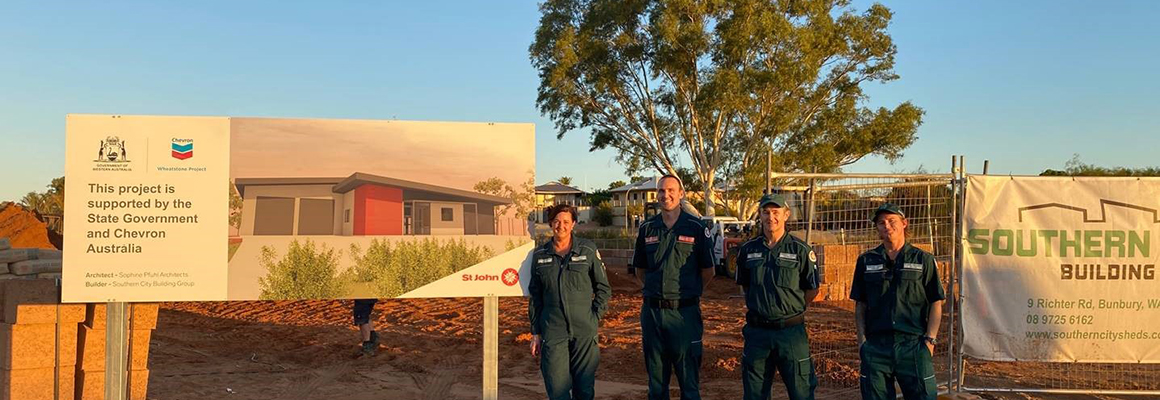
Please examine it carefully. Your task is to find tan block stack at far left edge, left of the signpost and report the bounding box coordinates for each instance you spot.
[0,279,85,400]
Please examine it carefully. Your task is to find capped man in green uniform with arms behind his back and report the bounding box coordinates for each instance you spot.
[737,191,818,400]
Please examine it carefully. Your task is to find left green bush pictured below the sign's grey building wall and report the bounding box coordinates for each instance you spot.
[258,239,345,300]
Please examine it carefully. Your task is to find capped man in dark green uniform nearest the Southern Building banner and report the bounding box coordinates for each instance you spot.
[850,203,945,400]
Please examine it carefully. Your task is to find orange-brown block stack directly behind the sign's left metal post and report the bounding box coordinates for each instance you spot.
[75,303,158,400]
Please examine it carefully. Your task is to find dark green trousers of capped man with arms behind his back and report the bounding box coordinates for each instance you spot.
[741,323,818,400]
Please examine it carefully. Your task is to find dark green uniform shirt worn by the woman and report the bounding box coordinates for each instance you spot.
[528,237,612,340]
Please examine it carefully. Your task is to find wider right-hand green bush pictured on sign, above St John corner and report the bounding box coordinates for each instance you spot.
[343,239,494,298]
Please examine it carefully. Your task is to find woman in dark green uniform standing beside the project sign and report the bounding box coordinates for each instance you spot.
[528,204,612,400]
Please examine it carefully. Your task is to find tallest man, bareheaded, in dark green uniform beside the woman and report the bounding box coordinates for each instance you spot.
[630,175,713,400]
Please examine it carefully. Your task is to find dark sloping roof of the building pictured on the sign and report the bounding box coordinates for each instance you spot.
[234,173,512,204]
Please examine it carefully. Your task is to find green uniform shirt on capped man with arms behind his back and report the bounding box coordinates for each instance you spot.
[737,233,818,321]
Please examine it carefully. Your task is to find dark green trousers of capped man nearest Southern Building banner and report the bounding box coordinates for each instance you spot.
[858,334,938,400]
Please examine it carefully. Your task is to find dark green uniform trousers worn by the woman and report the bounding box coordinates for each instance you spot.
[539,336,600,400]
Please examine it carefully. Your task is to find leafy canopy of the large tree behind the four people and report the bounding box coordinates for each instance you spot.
[529,0,922,217]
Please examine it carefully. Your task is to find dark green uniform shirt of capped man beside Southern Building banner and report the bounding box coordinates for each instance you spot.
[850,243,947,335]
